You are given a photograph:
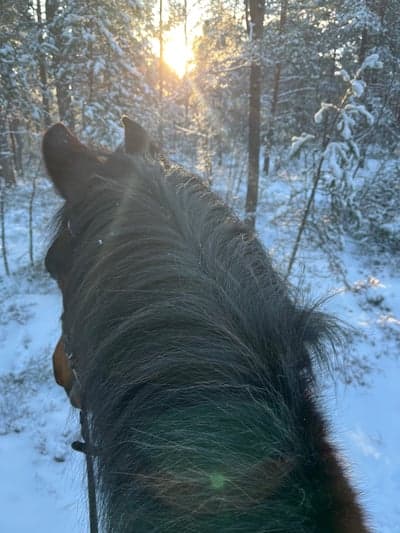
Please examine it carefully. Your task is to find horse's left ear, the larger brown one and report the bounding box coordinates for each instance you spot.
[43,123,98,202]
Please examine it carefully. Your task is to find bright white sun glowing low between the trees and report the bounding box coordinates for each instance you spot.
[164,25,193,78]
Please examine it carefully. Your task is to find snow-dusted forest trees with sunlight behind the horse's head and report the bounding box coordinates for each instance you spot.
[0,0,400,270]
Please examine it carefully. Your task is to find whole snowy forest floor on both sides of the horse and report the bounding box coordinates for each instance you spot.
[0,169,400,533]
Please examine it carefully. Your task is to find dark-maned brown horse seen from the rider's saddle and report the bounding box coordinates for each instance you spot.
[43,118,369,533]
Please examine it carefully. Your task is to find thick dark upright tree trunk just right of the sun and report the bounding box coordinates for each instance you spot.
[246,0,265,229]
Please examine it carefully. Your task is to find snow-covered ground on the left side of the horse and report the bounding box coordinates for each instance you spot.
[0,183,87,533]
